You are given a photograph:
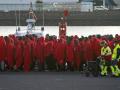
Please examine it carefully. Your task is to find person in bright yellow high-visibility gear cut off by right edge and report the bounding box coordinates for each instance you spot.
[112,40,120,76]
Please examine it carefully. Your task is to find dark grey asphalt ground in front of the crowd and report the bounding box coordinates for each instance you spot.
[0,72,120,90]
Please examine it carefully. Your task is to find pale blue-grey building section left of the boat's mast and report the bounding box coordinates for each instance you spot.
[0,0,36,12]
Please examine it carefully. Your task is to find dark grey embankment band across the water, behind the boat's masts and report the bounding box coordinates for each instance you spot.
[0,10,120,26]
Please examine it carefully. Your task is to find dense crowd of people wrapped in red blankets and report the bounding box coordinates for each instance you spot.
[0,34,120,74]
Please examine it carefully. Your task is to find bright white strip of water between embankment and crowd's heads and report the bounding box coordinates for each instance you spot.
[0,26,120,37]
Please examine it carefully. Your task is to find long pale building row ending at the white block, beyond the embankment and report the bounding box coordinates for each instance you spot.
[0,0,93,12]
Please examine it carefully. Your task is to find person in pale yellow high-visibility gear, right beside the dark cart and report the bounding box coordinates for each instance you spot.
[100,41,112,75]
